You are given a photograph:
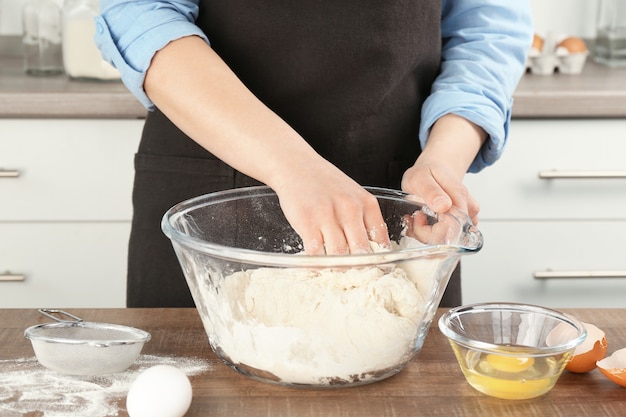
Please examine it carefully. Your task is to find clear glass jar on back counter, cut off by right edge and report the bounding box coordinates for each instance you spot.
[594,0,626,66]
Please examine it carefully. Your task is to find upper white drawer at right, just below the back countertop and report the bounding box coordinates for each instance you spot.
[466,119,626,220]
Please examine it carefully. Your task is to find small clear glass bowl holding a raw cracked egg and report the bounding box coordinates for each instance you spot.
[439,303,587,400]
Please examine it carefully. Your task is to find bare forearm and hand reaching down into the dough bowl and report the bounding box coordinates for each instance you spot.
[144,36,389,255]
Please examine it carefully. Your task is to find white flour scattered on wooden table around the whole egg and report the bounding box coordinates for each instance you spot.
[0,355,211,417]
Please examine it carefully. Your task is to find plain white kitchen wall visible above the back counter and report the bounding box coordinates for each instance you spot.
[0,0,599,39]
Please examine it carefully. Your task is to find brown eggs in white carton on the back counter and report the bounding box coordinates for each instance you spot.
[526,33,589,75]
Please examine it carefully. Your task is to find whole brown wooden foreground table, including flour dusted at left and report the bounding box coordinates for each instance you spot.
[0,309,626,417]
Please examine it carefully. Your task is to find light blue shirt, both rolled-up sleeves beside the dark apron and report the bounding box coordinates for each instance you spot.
[95,0,533,172]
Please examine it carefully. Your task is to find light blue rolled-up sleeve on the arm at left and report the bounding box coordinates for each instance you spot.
[94,0,208,110]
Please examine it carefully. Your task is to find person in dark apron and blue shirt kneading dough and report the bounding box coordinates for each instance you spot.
[96,0,532,307]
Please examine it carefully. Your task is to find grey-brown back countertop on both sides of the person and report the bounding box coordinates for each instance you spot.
[0,46,626,118]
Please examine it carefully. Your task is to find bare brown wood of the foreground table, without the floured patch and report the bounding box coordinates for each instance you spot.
[0,309,626,417]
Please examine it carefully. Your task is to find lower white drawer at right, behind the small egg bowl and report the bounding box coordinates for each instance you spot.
[461,221,626,308]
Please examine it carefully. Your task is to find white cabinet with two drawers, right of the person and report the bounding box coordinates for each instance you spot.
[462,119,626,308]
